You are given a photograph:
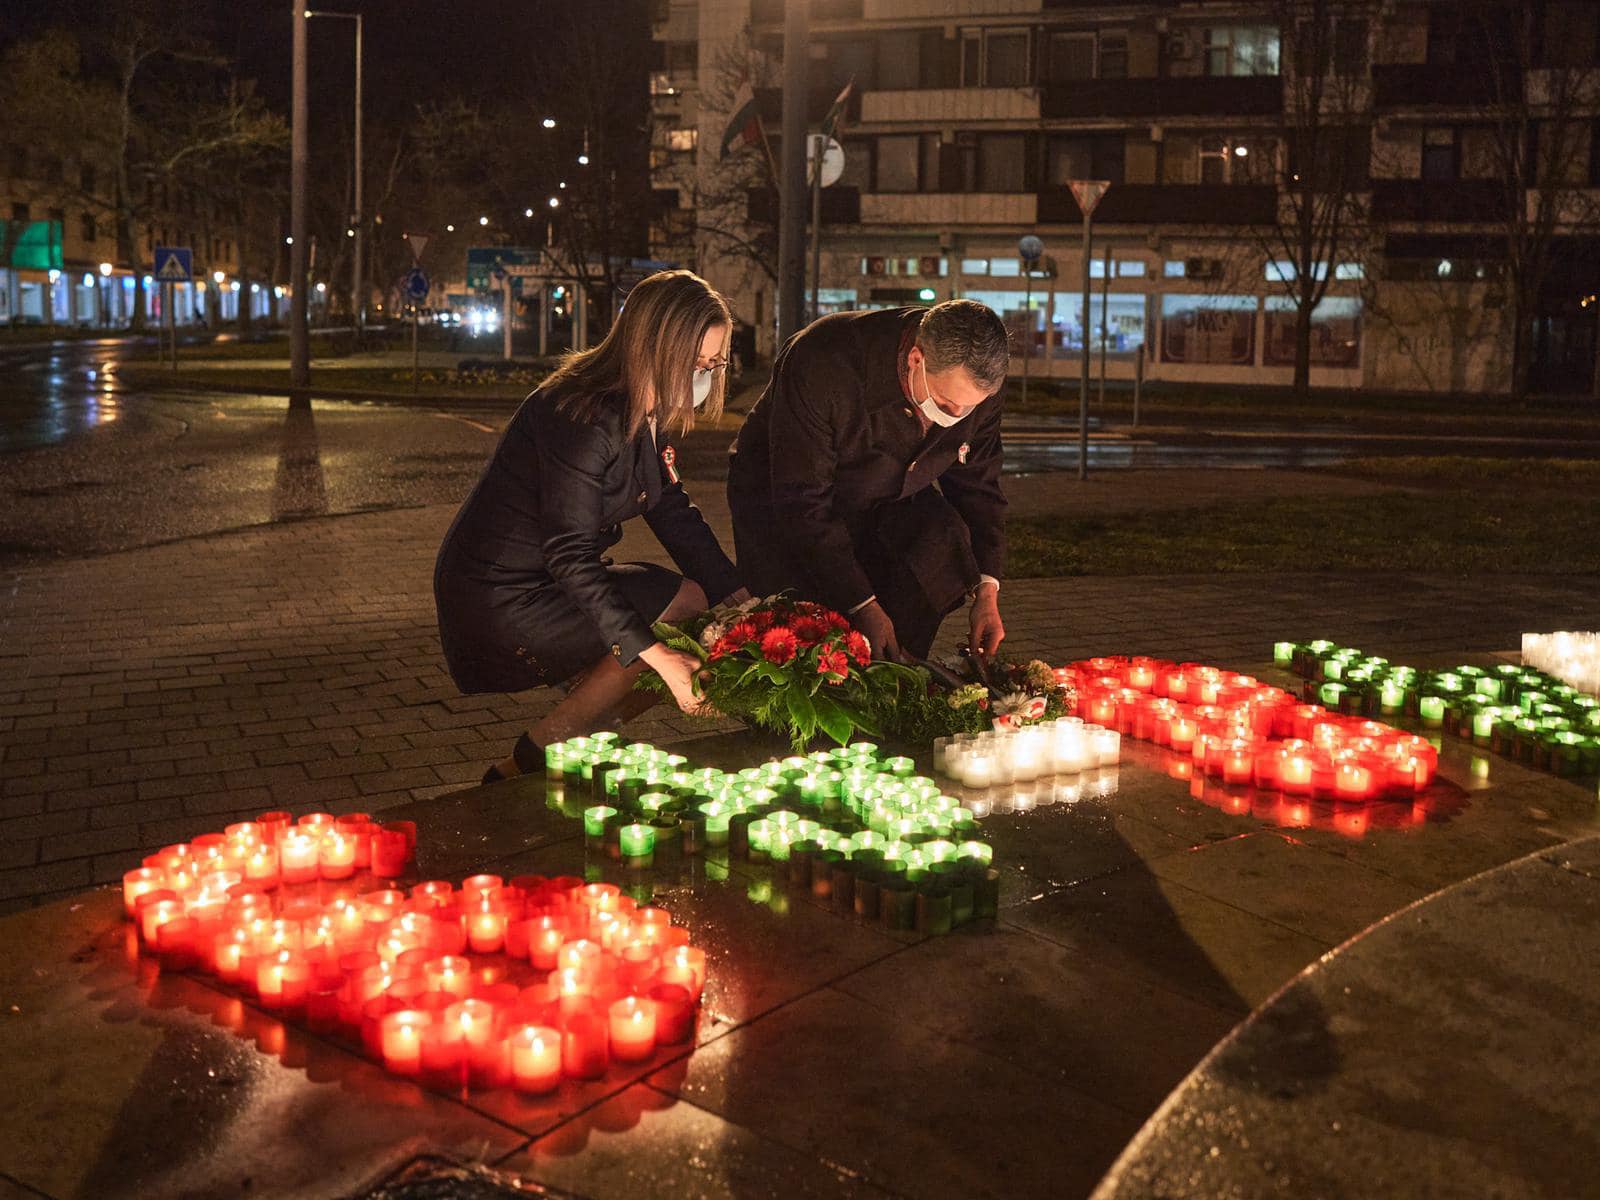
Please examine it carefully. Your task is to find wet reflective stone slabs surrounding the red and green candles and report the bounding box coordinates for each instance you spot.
[0,713,1600,1200]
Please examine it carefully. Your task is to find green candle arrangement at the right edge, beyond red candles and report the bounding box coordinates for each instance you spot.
[1274,642,1600,778]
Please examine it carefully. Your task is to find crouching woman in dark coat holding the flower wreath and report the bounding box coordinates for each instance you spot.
[434,270,746,782]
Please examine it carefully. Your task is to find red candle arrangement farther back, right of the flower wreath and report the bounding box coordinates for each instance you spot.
[1059,658,1438,802]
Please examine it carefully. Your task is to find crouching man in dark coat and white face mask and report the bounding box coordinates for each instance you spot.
[728,301,1010,658]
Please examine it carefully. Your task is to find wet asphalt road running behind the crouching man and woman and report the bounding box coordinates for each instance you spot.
[0,341,1600,566]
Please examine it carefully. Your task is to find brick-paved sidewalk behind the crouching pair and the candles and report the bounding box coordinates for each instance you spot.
[0,472,1600,909]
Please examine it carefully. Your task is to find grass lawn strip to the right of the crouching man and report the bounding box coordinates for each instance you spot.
[1008,458,1600,576]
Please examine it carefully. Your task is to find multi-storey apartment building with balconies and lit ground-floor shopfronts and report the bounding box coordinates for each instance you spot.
[651,0,1600,394]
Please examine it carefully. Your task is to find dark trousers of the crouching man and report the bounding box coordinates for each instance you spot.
[730,488,978,658]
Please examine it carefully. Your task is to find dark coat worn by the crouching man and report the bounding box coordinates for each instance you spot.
[728,309,1005,611]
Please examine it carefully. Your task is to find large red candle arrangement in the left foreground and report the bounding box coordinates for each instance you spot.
[123,813,706,1094]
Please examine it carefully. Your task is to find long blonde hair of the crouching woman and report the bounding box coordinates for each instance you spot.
[542,270,733,437]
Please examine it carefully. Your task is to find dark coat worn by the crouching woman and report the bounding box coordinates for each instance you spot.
[438,392,741,666]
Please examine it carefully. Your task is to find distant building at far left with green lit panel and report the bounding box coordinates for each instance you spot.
[0,141,286,328]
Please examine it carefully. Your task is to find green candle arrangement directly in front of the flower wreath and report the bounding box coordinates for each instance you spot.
[546,733,998,933]
